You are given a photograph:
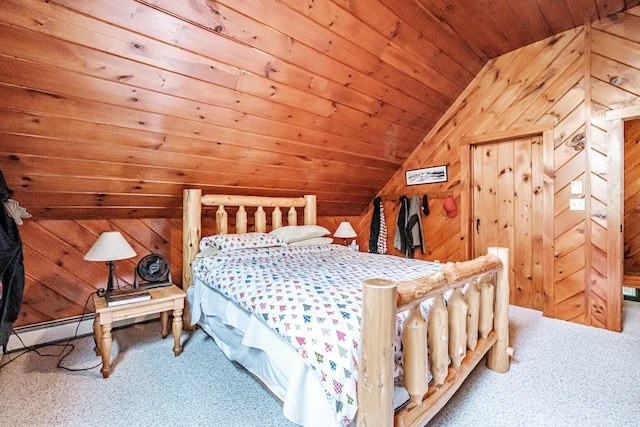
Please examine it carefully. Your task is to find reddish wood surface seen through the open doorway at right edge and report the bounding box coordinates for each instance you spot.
[624,119,640,288]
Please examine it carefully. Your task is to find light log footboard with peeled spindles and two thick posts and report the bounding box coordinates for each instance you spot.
[357,248,513,426]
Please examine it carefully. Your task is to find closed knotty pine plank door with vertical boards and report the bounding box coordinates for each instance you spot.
[471,135,543,310]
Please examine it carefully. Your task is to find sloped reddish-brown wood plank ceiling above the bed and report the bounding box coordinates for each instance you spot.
[0,0,640,218]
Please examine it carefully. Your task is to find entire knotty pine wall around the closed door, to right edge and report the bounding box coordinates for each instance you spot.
[359,8,640,330]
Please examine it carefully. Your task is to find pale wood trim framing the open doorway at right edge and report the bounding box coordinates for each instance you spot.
[605,106,640,331]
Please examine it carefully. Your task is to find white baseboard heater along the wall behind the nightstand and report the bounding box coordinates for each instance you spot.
[5,313,159,353]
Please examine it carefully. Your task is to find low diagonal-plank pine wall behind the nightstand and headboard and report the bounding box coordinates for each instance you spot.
[14,217,358,327]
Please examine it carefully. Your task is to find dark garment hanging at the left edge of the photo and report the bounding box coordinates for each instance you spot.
[0,171,24,352]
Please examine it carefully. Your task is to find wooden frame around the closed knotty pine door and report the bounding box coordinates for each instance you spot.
[459,123,555,317]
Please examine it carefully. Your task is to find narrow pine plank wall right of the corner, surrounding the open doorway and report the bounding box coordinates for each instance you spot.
[586,7,640,330]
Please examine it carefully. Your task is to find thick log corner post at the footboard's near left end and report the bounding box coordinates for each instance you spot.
[357,279,396,427]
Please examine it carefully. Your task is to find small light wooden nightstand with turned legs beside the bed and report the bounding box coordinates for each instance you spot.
[93,285,186,378]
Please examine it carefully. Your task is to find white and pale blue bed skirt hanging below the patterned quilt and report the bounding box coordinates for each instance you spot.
[187,279,408,427]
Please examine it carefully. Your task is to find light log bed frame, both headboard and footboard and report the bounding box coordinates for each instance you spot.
[182,189,513,426]
